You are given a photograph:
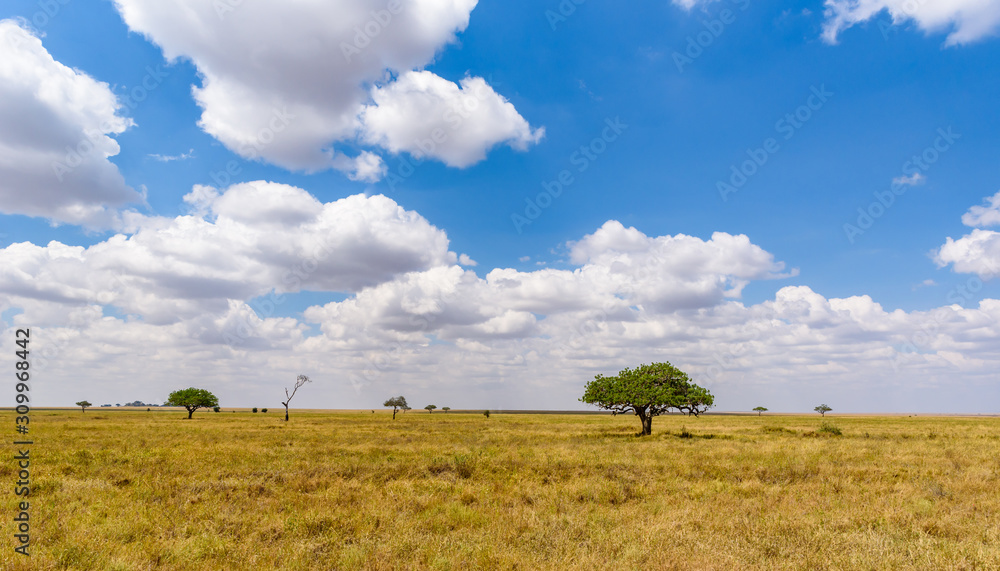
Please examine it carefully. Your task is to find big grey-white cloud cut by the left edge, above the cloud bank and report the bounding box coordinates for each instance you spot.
[0,20,143,228]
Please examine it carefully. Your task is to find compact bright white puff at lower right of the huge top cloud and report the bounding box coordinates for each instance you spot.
[361,71,545,168]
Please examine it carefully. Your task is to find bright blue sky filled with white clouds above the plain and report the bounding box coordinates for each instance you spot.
[0,0,1000,413]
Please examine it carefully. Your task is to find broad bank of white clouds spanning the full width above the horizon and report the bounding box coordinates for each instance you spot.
[0,208,1000,411]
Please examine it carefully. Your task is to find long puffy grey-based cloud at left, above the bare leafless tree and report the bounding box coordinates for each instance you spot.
[0,181,456,325]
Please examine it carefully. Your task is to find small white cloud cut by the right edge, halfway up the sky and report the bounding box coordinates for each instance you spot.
[931,192,1000,280]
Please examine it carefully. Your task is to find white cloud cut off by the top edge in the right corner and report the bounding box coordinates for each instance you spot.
[823,0,1000,46]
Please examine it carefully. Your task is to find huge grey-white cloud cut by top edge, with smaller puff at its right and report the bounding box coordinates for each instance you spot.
[108,0,541,181]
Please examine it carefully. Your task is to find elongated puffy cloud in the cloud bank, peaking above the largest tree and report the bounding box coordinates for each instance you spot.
[305,221,787,350]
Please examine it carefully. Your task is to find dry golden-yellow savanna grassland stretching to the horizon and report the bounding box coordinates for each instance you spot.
[0,409,1000,571]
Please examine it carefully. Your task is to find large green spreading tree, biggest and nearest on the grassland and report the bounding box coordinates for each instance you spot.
[580,363,715,435]
